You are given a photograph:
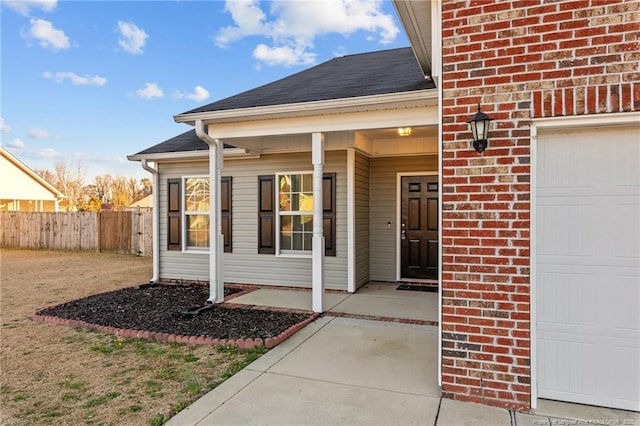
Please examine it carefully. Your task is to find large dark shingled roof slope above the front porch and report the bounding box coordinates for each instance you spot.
[180,47,435,115]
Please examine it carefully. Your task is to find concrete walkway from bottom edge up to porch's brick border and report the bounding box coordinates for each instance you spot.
[168,317,444,425]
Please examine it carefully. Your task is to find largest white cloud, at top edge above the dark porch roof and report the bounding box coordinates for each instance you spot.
[212,0,400,66]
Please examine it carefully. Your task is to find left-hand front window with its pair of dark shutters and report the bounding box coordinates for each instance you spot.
[167,176,232,252]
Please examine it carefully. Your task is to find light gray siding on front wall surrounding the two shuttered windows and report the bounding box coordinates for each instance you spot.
[160,151,347,290]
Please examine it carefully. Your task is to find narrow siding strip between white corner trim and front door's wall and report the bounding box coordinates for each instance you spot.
[355,152,370,287]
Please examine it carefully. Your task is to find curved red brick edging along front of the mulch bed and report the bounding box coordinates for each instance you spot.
[31,313,320,349]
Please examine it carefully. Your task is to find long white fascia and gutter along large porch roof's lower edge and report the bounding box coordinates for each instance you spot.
[173,89,438,124]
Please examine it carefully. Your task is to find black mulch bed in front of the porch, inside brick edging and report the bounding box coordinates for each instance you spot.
[37,285,311,339]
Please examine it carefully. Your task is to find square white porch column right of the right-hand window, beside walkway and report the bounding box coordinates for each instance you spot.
[311,133,324,313]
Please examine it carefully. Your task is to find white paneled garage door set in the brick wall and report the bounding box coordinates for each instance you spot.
[536,121,640,410]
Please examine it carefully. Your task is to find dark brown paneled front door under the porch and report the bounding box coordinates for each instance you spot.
[400,176,438,280]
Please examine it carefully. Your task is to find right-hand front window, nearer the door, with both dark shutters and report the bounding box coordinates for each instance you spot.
[258,173,336,256]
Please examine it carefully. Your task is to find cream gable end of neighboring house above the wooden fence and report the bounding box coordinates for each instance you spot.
[0,147,65,200]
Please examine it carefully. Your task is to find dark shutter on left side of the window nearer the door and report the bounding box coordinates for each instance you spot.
[258,175,276,254]
